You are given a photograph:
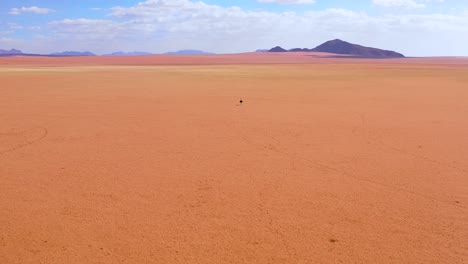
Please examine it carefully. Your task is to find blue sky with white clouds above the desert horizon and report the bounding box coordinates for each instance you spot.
[0,0,468,56]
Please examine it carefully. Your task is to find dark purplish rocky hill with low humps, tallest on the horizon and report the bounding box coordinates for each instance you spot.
[268,39,405,58]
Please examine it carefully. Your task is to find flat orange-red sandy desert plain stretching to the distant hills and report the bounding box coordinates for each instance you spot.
[0,54,468,264]
